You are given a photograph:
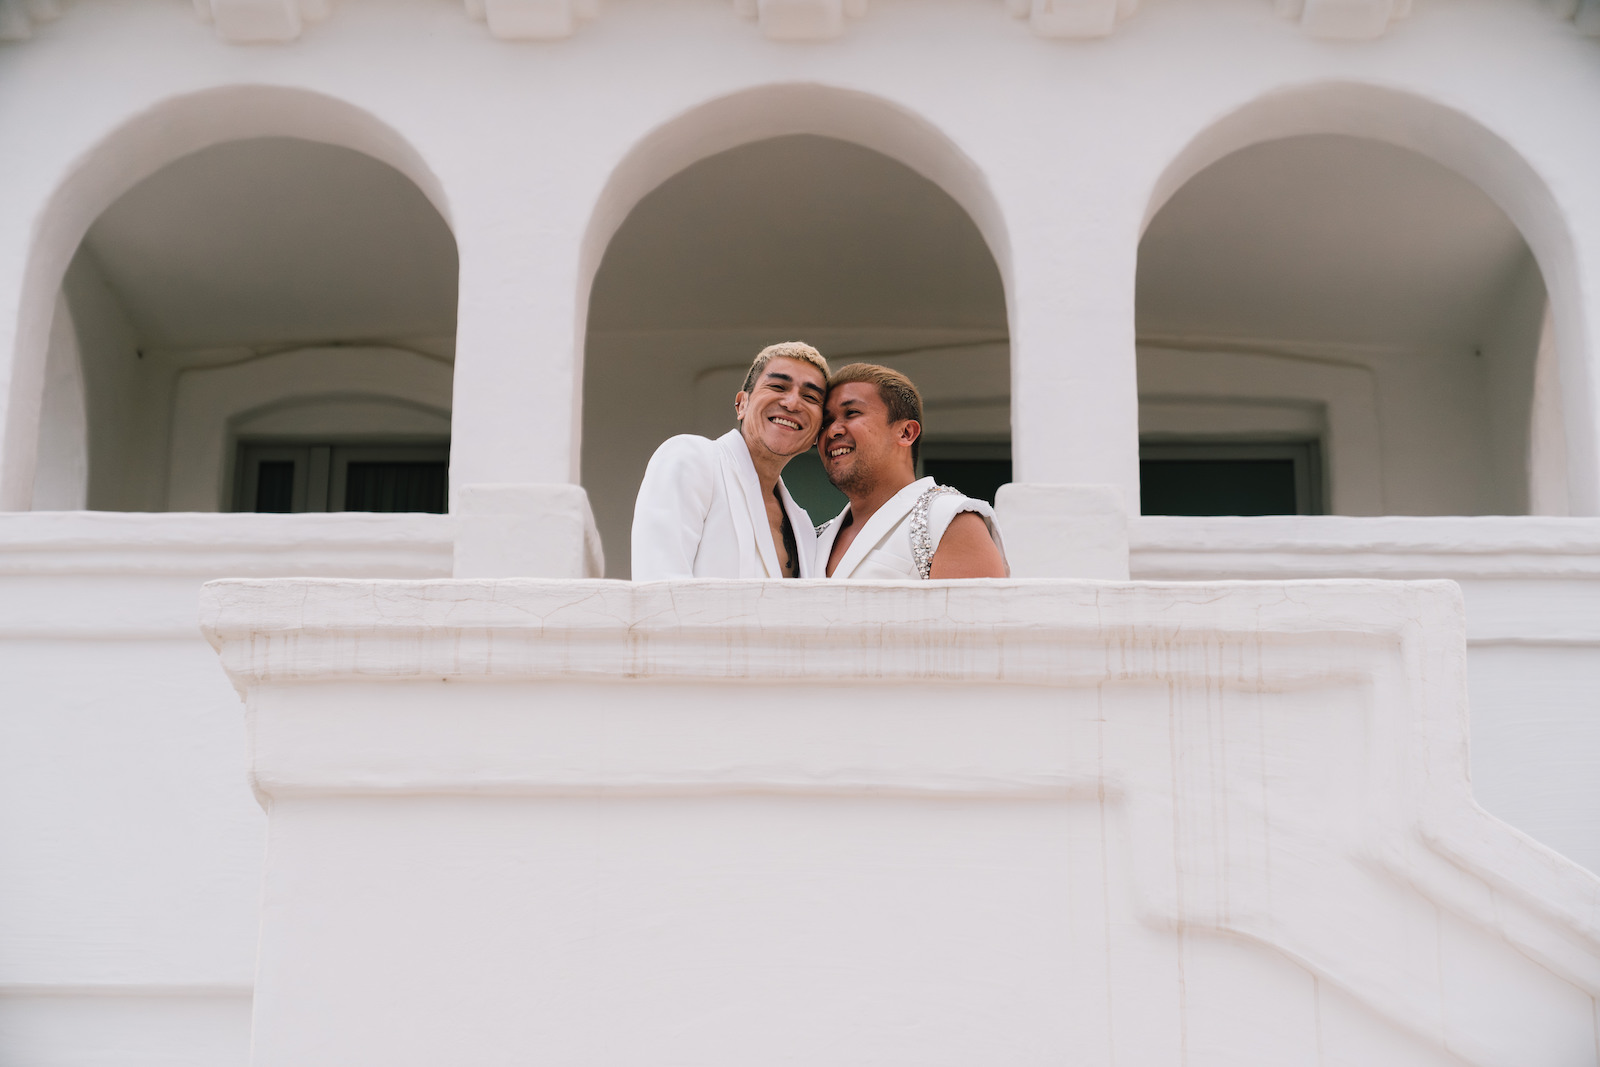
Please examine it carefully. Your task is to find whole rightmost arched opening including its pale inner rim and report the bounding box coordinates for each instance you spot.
[1138,85,1592,515]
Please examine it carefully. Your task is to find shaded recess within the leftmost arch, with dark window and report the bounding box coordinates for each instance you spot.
[32,136,458,512]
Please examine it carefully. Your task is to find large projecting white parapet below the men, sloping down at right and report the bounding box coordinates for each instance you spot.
[202,579,1600,1067]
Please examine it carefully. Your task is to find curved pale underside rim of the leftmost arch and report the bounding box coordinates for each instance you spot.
[0,85,451,510]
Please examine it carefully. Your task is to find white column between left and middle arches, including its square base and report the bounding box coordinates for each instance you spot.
[450,160,603,577]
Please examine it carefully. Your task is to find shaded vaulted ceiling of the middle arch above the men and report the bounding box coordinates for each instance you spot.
[589,134,1006,334]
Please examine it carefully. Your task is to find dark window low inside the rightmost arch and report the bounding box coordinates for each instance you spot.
[1139,442,1322,515]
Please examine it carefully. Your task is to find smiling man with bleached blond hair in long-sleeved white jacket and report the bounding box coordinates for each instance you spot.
[634,341,827,582]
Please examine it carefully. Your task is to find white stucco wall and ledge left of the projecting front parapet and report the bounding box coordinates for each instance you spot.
[0,512,453,1067]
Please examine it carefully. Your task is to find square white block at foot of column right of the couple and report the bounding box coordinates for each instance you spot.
[995,483,1128,581]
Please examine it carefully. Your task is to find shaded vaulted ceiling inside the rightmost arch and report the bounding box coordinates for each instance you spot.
[1138,136,1528,349]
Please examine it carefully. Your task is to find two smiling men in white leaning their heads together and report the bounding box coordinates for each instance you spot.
[634,341,1010,581]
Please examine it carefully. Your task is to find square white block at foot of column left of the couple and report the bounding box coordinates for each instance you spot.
[451,485,605,577]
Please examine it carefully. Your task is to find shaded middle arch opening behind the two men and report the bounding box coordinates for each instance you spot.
[582,133,1010,577]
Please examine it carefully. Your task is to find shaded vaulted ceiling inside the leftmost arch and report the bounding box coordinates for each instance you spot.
[85,138,456,349]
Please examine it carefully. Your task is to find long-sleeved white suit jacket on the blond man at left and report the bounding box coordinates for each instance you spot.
[634,429,821,582]
